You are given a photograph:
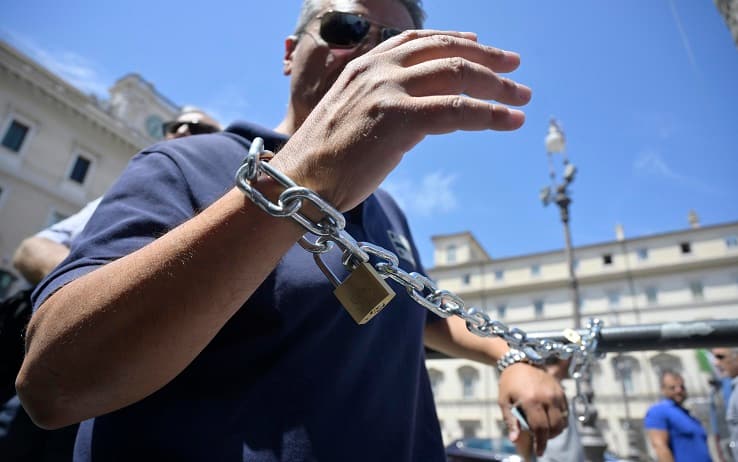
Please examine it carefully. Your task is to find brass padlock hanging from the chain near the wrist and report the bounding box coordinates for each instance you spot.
[314,254,395,324]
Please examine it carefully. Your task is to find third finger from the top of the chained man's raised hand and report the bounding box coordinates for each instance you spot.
[401,56,531,106]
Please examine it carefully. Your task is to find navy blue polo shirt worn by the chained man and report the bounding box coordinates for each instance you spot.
[34,124,445,462]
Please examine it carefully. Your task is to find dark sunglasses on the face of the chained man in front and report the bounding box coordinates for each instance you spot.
[317,11,402,48]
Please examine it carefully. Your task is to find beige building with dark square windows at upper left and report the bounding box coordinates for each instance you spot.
[0,41,179,297]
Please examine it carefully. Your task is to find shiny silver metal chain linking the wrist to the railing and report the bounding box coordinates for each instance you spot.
[236,138,602,372]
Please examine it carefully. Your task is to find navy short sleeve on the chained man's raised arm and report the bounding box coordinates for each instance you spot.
[32,151,194,309]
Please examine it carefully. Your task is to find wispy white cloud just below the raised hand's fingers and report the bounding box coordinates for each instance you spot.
[382,171,458,217]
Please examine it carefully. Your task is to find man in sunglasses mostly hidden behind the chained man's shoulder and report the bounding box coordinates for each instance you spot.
[0,106,221,462]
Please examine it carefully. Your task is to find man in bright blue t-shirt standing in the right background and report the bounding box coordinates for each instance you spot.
[643,371,712,462]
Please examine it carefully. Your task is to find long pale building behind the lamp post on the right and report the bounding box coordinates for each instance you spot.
[427,219,738,454]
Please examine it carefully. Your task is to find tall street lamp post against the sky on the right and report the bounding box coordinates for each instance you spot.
[540,119,607,462]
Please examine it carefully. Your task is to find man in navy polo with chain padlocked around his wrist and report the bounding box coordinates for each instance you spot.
[17,0,567,461]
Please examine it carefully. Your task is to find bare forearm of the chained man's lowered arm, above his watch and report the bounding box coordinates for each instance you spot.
[424,316,508,365]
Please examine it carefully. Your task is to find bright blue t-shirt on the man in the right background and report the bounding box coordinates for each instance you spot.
[643,399,712,462]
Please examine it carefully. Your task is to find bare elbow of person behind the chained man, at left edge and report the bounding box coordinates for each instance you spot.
[13,236,69,284]
